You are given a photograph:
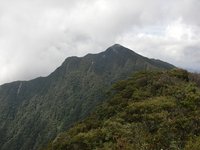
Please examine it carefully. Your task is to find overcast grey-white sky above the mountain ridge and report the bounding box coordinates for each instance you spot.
[0,0,200,84]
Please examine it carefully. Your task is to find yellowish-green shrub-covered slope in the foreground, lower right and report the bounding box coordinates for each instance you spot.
[46,70,200,150]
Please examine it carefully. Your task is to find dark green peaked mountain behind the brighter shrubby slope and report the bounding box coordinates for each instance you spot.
[0,44,174,150]
